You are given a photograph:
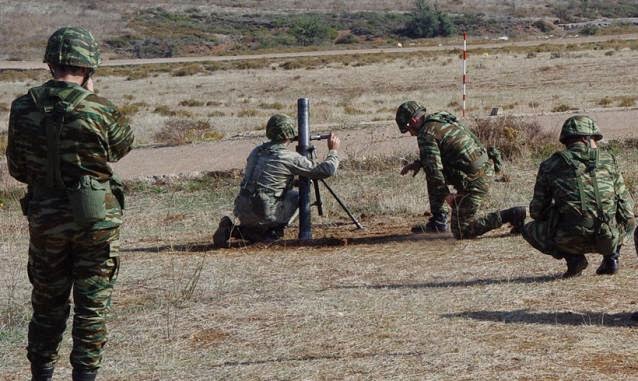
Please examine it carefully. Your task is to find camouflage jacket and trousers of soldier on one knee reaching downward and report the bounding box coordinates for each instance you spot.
[417,112,503,239]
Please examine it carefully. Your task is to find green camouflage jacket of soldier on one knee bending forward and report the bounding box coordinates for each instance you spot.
[417,112,489,213]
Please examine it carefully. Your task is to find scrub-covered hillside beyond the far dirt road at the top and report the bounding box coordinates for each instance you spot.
[0,0,638,60]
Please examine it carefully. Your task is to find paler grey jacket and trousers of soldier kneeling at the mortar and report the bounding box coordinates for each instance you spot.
[234,142,339,235]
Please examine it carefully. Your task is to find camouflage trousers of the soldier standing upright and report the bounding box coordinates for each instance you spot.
[27,201,119,371]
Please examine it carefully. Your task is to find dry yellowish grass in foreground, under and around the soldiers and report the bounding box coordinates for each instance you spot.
[0,151,638,380]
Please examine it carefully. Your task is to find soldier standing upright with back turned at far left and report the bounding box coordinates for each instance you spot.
[7,27,133,381]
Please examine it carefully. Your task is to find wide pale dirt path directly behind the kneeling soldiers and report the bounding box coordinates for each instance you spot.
[114,109,638,179]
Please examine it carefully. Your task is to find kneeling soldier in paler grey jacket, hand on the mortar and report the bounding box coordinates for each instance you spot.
[213,114,340,247]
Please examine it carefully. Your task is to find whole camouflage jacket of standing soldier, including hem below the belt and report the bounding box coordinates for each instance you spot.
[7,80,133,229]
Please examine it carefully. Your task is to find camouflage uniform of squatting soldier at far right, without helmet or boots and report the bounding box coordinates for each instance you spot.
[523,142,634,258]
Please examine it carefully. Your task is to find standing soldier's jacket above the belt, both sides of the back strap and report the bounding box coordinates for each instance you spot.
[7,80,133,186]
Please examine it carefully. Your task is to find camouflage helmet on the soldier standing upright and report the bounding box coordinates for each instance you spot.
[44,27,101,70]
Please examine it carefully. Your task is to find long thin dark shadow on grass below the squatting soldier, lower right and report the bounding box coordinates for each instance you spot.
[441,310,638,327]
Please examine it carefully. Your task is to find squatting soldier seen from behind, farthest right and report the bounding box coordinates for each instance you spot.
[522,116,635,278]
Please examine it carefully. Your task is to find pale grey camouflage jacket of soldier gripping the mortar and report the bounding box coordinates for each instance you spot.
[241,142,339,198]
